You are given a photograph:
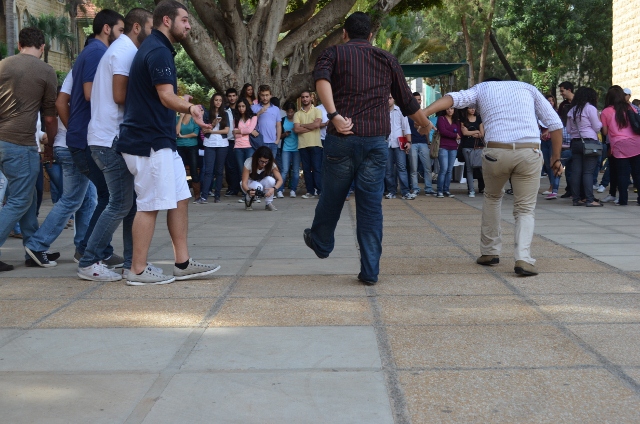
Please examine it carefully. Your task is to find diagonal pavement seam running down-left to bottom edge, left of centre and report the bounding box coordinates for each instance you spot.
[125,201,288,424]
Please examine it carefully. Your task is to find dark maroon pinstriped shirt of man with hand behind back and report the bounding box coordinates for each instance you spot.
[313,39,420,137]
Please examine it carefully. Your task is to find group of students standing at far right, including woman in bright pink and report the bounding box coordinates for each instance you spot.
[541,81,640,207]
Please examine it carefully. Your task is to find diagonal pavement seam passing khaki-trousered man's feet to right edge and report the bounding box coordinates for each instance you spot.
[409,200,640,397]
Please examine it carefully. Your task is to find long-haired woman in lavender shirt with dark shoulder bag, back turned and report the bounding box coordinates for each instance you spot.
[567,87,602,207]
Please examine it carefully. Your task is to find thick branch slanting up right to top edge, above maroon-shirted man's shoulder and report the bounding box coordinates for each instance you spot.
[273,0,356,62]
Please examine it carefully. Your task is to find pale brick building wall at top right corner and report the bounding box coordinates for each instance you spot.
[612,0,640,99]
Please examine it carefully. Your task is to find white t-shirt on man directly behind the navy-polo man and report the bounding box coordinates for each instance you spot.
[87,34,138,147]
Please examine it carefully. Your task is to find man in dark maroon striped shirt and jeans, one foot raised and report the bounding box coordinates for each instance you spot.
[304,12,432,285]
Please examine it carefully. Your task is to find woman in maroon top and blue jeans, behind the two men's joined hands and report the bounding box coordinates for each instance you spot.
[436,107,462,197]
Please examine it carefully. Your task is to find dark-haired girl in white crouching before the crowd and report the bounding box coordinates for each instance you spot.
[241,146,282,211]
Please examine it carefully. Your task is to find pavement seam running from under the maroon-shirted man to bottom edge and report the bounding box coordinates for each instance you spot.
[348,203,411,424]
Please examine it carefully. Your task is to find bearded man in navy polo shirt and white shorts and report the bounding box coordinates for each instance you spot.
[117,0,220,286]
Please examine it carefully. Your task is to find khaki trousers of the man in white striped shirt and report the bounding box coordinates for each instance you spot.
[480,148,544,265]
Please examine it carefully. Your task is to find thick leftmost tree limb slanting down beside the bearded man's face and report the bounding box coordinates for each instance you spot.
[182,21,238,91]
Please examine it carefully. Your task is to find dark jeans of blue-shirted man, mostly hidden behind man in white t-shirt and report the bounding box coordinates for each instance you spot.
[69,146,113,259]
